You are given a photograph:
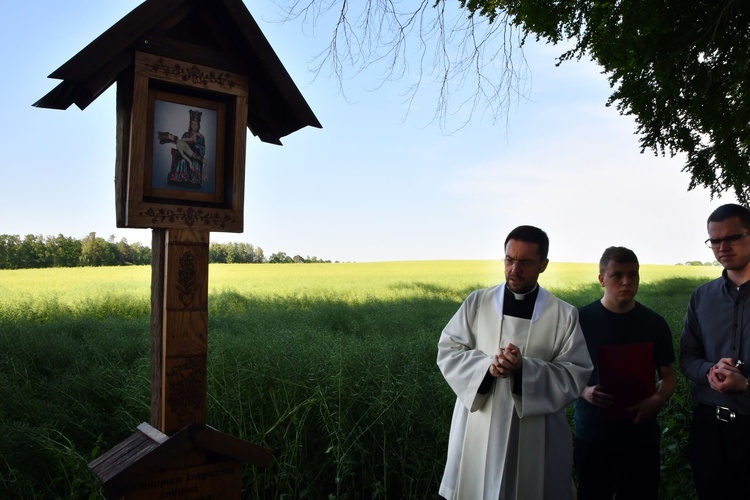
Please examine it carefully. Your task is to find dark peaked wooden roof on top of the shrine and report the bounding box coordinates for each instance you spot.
[34,0,321,144]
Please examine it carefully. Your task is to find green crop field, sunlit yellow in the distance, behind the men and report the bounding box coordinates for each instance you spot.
[0,261,720,498]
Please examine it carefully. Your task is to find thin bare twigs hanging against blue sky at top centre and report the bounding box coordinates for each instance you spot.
[268,0,529,131]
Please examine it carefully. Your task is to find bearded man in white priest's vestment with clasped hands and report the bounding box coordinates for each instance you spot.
[437,226,593,500]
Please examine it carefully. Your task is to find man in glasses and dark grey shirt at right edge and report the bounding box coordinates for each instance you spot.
[680,204,750,499]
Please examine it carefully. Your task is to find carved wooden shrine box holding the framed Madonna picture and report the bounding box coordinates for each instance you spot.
[116,52,248,232]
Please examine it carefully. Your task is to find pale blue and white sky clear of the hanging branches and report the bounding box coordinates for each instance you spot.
[0,0,735,264]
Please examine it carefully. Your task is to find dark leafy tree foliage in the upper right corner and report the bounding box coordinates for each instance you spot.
[458,0,750,204]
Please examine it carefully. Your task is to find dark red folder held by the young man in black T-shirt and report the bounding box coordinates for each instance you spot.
[599,342,656,419]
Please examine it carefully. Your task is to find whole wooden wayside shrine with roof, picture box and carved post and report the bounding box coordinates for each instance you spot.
[34,0,320,499]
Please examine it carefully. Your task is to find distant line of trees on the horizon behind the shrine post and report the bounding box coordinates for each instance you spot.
[0,232,331,269]
